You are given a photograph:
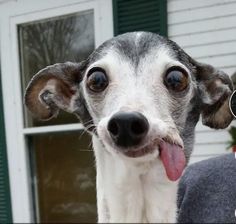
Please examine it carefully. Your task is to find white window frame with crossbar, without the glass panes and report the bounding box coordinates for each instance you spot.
[0,0,113,223]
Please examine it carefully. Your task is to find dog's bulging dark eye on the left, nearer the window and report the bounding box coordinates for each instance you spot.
[87,68,108,92]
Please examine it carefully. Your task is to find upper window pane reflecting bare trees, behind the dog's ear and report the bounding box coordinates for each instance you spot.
[18,10,94,127]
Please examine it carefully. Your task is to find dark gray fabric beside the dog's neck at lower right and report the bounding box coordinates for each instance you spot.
[177,153,236,223]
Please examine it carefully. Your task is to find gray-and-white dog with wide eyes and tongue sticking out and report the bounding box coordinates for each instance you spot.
[25,32,233,223]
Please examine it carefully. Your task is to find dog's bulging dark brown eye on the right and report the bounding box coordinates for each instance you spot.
[164,67,188,92]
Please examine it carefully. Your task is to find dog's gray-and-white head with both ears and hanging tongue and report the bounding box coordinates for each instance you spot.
[25,32,233,180]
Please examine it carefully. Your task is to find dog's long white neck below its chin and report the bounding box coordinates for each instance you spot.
[93,136,177,223]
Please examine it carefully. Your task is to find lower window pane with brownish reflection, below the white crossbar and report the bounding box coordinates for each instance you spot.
[28,131,97,223]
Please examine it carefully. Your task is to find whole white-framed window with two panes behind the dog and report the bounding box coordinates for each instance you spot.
[1,0,113,222]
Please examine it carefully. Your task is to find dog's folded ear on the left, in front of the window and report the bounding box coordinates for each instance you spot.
[25,62,85,120]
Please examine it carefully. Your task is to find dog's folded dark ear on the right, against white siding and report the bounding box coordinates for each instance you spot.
[193,61,233,129]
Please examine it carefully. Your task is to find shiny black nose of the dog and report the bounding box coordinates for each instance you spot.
[107,112,149,147]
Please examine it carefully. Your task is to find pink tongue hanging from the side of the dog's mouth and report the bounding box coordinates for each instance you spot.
[159,141,186,181]
